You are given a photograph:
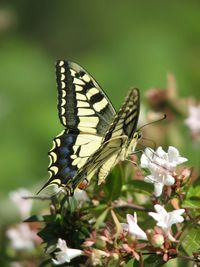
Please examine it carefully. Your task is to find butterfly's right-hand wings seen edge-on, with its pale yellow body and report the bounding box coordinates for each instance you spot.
[72,89,140,190]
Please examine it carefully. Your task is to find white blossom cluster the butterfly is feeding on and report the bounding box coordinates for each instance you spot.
[140,146,187,197]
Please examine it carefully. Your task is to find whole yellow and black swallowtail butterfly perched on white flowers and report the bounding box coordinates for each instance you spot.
[39,60,141,195]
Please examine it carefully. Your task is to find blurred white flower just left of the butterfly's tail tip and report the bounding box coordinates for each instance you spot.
[9,188,33,220]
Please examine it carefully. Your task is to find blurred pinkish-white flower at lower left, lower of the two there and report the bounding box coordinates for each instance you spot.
[6,223,37,250]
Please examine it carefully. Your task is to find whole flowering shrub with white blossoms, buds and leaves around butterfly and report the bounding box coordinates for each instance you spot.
[6,74,200,267]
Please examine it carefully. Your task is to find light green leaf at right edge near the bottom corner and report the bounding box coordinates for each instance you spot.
[180,223,200,256]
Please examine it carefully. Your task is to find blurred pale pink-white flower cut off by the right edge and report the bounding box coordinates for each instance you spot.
[185,105,200,134]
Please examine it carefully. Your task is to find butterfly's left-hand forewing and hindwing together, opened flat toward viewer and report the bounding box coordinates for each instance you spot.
[38,61,116,195]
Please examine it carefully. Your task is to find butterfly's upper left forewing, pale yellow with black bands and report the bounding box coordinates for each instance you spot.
[56,60,116,136]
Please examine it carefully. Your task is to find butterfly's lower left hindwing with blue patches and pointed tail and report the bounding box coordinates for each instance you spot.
[40,130,102,194]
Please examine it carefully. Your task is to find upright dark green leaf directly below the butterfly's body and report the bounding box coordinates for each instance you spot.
[105,168,123,201]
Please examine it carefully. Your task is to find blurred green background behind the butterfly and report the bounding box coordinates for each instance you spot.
[0,0,200,198]
